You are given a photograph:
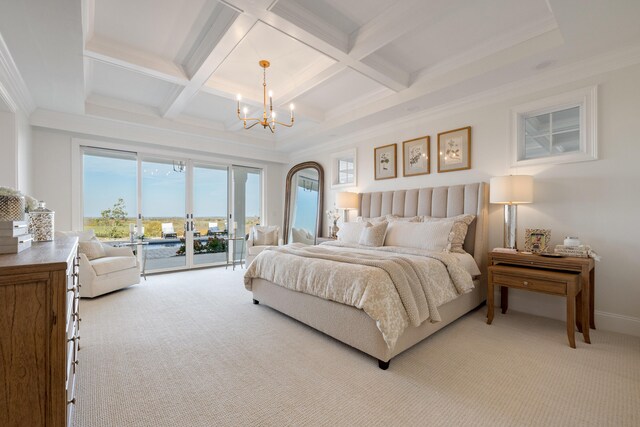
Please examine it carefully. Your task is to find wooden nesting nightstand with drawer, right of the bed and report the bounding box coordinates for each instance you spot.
[487,252,595,348]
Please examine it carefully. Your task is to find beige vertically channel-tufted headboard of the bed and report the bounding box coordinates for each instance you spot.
[358,182,489,266]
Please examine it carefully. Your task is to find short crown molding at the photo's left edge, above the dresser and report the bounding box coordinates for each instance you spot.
[0,34,36,116]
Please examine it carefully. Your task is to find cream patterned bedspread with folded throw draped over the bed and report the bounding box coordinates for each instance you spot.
[245,242,473,348]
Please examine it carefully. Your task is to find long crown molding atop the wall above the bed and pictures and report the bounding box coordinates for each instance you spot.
[288,45,640,159]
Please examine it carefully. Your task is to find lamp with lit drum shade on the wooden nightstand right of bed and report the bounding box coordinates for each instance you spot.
[489,175,533,249]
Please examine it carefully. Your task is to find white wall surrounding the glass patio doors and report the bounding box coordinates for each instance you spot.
[33,128,284,237]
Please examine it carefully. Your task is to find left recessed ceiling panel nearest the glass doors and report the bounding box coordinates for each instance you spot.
[87,61,177,108]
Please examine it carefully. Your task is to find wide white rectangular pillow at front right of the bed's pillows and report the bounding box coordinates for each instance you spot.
[384,221,453,251]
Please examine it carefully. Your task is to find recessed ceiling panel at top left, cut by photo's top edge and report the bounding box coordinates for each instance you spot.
[94,0,218,62]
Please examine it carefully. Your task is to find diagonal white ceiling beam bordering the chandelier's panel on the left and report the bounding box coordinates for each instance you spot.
[161,11,257,118]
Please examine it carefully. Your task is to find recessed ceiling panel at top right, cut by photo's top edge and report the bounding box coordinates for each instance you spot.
[376,0,553,73]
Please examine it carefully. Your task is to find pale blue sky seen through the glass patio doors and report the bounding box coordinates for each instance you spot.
[83,154,261,217]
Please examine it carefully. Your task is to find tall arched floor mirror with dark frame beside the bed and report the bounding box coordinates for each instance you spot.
[283,162,324,245]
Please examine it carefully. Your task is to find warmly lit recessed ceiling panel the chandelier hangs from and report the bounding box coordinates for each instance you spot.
[207,22,335,102]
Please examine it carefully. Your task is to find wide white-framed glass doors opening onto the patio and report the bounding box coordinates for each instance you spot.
[83,147,262,272]
